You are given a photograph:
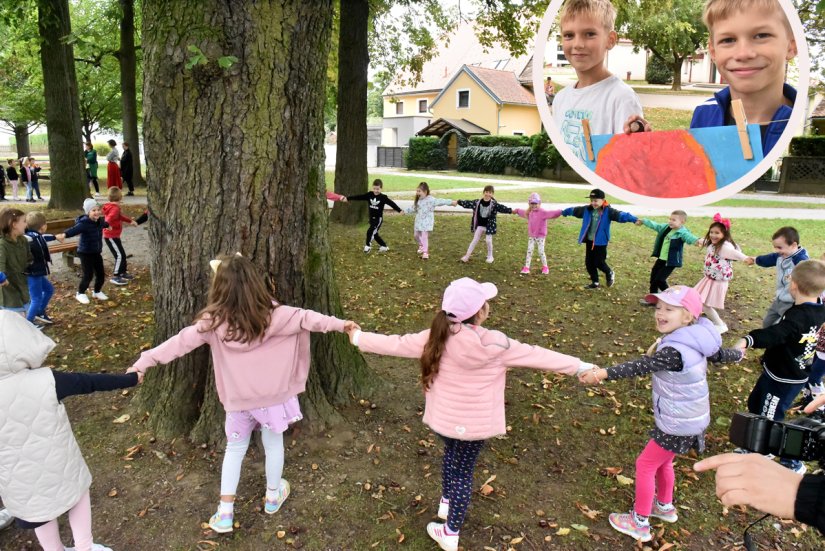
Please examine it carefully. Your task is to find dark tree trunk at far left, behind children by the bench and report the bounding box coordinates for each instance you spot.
[37,0,88,209]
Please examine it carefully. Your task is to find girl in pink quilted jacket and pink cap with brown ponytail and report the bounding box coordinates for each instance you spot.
[347,277,592,550]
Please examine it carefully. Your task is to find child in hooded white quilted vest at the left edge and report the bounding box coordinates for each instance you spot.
[0,310,141,551]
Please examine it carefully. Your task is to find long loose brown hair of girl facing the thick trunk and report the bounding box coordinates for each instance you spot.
[195,255,276,344]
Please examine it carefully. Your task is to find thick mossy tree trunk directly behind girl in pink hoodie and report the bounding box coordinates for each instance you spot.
[139,0,371,441]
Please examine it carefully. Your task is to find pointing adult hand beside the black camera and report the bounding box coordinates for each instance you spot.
[693,453,802,519]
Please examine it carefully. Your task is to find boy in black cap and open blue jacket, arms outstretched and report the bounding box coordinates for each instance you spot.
[561,189,638,289]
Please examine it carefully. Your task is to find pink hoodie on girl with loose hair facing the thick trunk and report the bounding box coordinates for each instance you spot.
[133,303,344,411]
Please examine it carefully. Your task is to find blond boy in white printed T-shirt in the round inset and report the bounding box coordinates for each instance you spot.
[553,0,642,159]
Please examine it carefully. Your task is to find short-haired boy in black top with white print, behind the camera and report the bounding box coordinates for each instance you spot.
[736,260,825,474]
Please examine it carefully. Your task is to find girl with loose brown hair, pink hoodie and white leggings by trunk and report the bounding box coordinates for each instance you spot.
[128,254,358,533]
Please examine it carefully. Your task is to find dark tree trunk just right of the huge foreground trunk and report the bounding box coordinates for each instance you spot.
[332,0,370,224]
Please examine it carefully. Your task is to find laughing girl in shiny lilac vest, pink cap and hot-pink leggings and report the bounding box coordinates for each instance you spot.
[579,285,743,542]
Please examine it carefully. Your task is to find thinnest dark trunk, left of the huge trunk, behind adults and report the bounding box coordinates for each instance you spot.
[117,0,146,186]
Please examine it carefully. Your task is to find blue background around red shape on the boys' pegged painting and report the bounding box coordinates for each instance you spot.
[581,124,763,189]
